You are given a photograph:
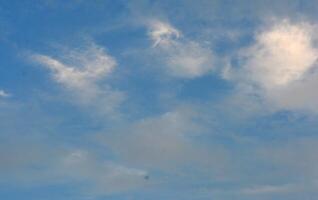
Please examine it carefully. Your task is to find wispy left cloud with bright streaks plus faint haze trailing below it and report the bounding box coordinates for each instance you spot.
[32,44,124,113]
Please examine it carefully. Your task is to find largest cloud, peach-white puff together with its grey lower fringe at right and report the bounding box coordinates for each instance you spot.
[225,20,318,112]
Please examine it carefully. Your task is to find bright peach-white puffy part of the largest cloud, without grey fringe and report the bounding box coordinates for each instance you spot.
[244,20,318,88]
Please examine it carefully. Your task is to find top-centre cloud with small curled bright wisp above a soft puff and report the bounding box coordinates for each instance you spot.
[148,20,214,79]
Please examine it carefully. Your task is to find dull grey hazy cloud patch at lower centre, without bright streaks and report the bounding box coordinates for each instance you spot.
[106,109,200,168]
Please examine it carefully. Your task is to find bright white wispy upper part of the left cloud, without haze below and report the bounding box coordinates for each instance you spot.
[33,45,116,89]
